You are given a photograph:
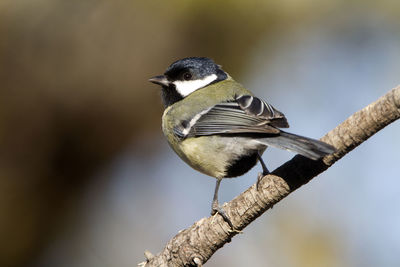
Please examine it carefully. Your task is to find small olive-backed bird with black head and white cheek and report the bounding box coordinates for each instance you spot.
[149,57,335,228]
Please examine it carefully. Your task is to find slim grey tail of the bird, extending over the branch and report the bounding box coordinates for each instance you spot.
[259,131,336,160]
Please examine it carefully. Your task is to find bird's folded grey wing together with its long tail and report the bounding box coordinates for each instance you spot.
[174,95,336,160]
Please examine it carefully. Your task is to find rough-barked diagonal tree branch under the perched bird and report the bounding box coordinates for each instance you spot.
[139,86,400,267]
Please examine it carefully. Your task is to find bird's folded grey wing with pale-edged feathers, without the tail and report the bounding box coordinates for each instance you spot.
[174,95,289,138]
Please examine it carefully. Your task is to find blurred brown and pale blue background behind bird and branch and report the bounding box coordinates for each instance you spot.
[0,0,400,267]
